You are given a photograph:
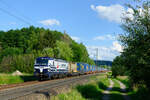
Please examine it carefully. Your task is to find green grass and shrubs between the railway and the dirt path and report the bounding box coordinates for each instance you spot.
[51,74,109,100]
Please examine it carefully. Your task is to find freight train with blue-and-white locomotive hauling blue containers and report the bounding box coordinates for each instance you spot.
[34,57,105,80]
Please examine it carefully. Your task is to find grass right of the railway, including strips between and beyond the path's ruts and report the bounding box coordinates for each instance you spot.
[52,75,150,100]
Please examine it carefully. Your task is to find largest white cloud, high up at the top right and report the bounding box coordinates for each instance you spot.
[91,4,133,23]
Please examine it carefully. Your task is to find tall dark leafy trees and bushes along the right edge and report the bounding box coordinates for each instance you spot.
[112,0,150,91]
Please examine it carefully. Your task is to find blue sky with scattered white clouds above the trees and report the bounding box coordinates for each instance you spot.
[0,0,133,61]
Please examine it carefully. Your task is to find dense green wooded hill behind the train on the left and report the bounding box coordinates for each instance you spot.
[0,26,94,73]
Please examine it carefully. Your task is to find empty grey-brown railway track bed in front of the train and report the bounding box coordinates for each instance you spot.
[0,73,102,100]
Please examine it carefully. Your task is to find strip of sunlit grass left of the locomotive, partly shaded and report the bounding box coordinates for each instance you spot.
[0,74,36,85]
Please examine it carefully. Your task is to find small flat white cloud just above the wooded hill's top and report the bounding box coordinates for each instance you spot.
[39,19,60,26]
